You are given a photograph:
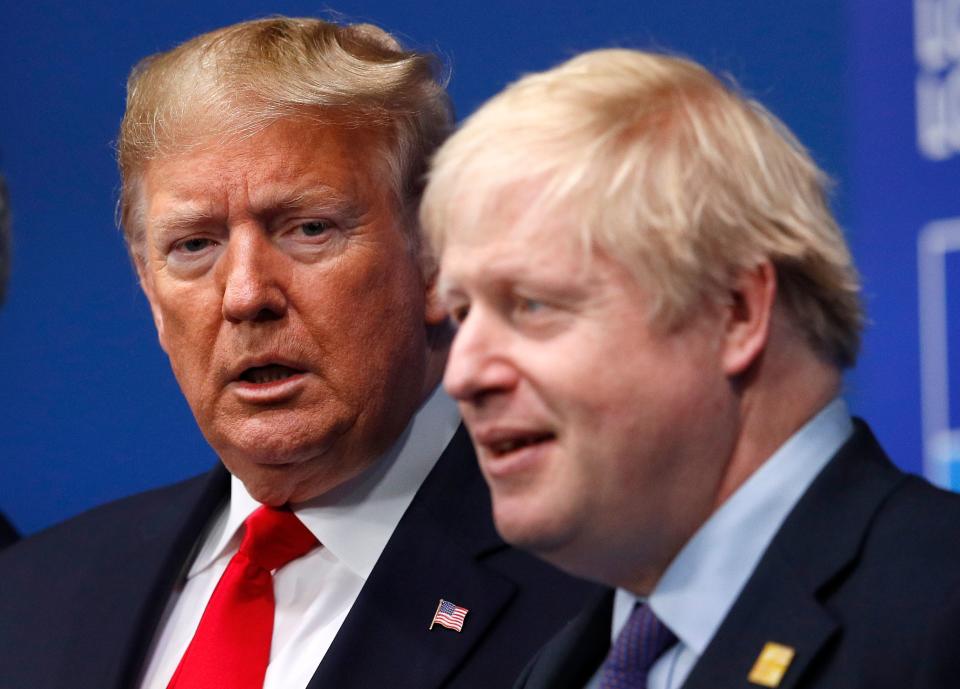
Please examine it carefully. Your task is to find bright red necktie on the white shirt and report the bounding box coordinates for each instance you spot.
[167,506,317,689]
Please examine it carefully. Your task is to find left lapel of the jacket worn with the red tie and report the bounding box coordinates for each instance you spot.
[61,467,227,689]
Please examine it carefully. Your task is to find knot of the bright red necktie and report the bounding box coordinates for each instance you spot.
[239,505,317,571]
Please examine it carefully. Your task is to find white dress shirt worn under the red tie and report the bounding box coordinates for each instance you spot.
[140,387,460,689]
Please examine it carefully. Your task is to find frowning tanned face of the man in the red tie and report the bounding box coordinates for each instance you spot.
[138,120,436,504]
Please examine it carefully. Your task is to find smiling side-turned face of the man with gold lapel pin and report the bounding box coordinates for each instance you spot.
[440,200,735,589]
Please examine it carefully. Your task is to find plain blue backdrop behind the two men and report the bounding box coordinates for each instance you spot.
[0,0,936,532]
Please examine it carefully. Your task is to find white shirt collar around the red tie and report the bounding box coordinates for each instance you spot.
[187,386,460,579]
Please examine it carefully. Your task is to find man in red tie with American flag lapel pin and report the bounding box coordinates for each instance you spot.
[0,18,586,689]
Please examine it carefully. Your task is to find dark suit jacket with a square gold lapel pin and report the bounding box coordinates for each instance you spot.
[517,422,960,689]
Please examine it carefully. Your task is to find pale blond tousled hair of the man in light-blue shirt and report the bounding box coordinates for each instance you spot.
[421,49,863,367]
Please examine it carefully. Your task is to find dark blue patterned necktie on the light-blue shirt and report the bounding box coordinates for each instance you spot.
[599,603,677,689]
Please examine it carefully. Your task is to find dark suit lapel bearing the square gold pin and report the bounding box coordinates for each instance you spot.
[683,422,904,689]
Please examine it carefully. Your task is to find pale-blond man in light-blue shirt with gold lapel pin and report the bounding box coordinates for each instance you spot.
[421,50,960,689]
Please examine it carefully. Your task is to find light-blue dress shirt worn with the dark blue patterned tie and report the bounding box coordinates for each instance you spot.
[586,398,853,689]
